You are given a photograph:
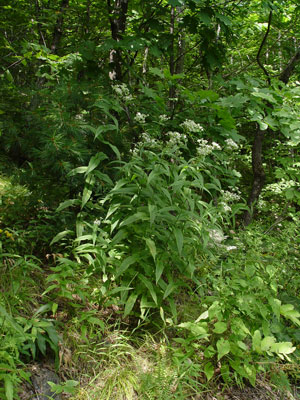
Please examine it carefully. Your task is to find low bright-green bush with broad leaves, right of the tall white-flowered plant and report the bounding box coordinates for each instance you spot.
[168,220,300,386]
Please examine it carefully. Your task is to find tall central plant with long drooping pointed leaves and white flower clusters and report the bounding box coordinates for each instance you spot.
[47,127,244,319]
